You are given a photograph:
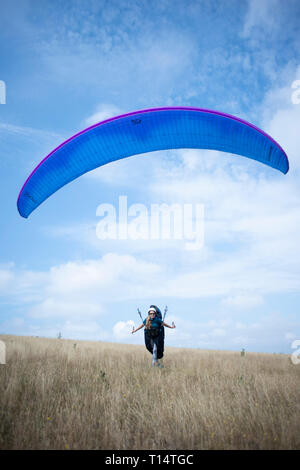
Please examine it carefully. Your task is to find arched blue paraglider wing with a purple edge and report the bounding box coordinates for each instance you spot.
[17,107,289,218]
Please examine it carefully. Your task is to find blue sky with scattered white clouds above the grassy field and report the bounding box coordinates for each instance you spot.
[0,0,300,354]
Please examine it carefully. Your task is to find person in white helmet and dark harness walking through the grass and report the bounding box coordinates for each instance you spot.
[132,306,176,367]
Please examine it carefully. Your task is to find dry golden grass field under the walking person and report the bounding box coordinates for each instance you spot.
[0,335,300,450]
